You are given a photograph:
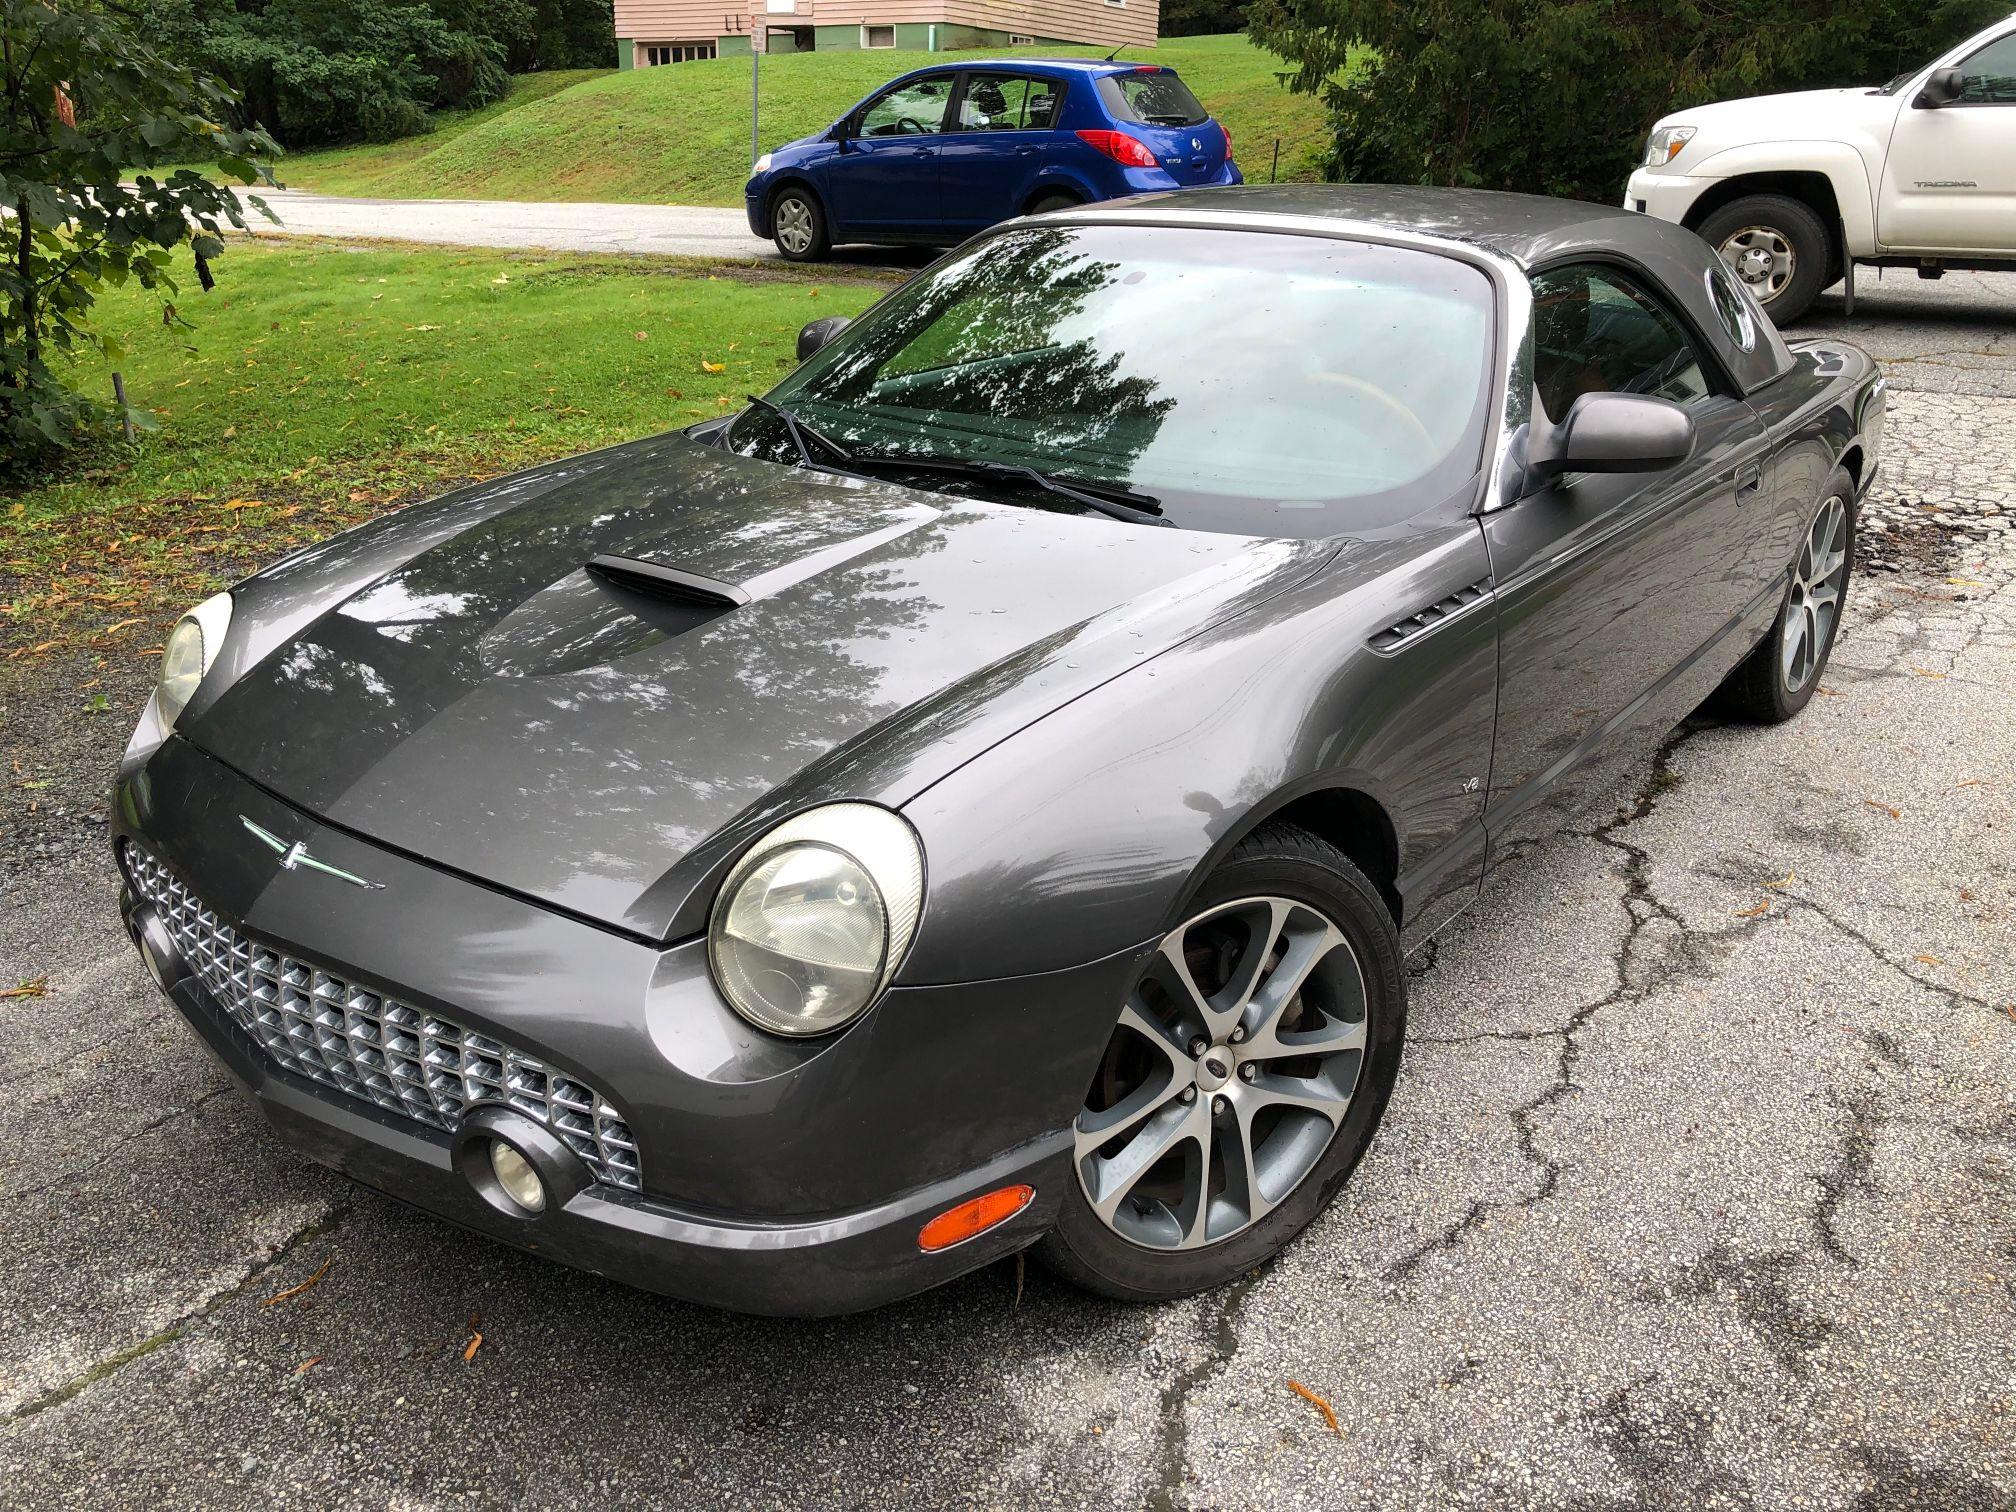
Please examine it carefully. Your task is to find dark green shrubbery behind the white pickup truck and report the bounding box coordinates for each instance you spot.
[1248,0,2008,202]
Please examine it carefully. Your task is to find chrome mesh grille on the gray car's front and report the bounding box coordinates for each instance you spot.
[125,843,641,1191]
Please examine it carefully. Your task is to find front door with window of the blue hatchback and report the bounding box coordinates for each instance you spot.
[827,71,958,238]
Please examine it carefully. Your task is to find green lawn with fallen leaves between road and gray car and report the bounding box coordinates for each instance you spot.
[0,240,889,655]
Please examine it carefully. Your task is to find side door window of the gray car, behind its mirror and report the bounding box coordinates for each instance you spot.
[1532,264,1710,419]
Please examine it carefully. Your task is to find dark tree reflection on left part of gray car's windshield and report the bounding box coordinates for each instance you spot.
[790,232,1175,478]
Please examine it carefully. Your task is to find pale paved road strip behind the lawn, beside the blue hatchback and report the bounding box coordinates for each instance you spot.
[226,190,921,266]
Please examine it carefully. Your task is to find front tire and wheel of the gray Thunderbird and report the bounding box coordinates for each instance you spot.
[1038,825,1407,1302]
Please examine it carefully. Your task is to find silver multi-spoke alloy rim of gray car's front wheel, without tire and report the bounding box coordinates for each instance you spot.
[1073,897,1369,1250]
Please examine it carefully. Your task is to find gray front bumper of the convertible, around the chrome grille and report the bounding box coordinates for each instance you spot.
[113,740,1137,1314]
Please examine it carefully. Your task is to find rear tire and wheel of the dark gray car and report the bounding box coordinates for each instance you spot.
[1716,468,1855,724]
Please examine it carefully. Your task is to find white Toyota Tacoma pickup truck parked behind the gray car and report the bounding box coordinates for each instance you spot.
[1625,16,2016,325]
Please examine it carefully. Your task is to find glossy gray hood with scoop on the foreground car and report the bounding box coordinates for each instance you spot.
[183,437,1335,937]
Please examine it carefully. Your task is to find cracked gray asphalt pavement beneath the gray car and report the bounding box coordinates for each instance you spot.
[0,274,2016,1512]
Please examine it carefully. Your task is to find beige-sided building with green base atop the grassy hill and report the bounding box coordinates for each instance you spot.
[615,0,1161,69]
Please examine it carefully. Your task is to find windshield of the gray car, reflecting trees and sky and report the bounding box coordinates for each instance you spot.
[728,226,1494,536]
